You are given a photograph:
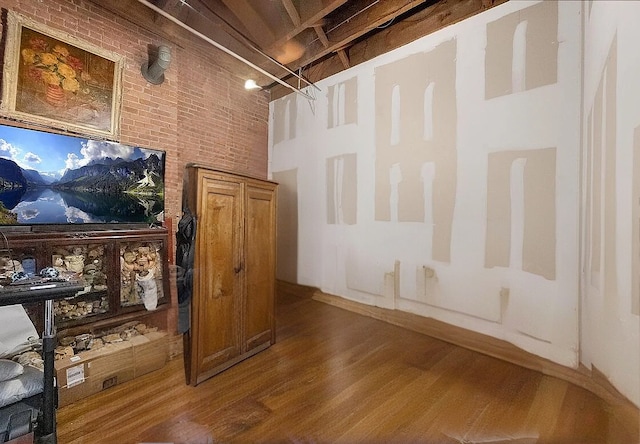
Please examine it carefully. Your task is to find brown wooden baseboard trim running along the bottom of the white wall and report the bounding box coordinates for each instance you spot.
[298,283,640,434]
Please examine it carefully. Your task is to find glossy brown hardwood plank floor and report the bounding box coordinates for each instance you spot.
[58,295,639,444]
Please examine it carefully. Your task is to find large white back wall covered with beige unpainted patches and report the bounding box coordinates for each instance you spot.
[270,1,640,403]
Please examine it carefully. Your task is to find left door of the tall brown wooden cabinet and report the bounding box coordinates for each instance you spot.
[190,174,243,384]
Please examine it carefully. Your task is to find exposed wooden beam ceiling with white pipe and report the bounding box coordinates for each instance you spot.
[95,0,506,98]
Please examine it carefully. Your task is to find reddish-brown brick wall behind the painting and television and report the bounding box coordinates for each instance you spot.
[0,0,269,328]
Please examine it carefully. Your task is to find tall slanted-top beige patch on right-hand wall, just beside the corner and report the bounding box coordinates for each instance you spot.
[585,38,618,299]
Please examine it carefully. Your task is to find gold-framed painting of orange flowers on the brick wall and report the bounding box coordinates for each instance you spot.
[0,11,124,140]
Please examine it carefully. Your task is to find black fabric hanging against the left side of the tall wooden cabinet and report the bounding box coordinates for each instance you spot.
[176,209,196,333]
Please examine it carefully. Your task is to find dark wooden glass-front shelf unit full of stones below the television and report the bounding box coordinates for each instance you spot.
[0,225,170,332]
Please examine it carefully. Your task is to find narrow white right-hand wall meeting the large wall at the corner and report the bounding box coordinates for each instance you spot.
[580,1,640,405]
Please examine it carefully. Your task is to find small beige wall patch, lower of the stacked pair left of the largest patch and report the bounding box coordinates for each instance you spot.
[327,154,358,225]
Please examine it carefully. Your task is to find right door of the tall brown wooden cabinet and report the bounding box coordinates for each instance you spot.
[243,182,276,352]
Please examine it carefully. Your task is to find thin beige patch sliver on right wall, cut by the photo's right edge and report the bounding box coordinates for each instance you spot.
[631,126,640,315]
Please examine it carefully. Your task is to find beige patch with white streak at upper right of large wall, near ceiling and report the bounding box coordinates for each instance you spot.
[485,1,558,99]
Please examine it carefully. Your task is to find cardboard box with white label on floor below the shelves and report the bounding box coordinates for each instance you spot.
[55,341,134,407]
